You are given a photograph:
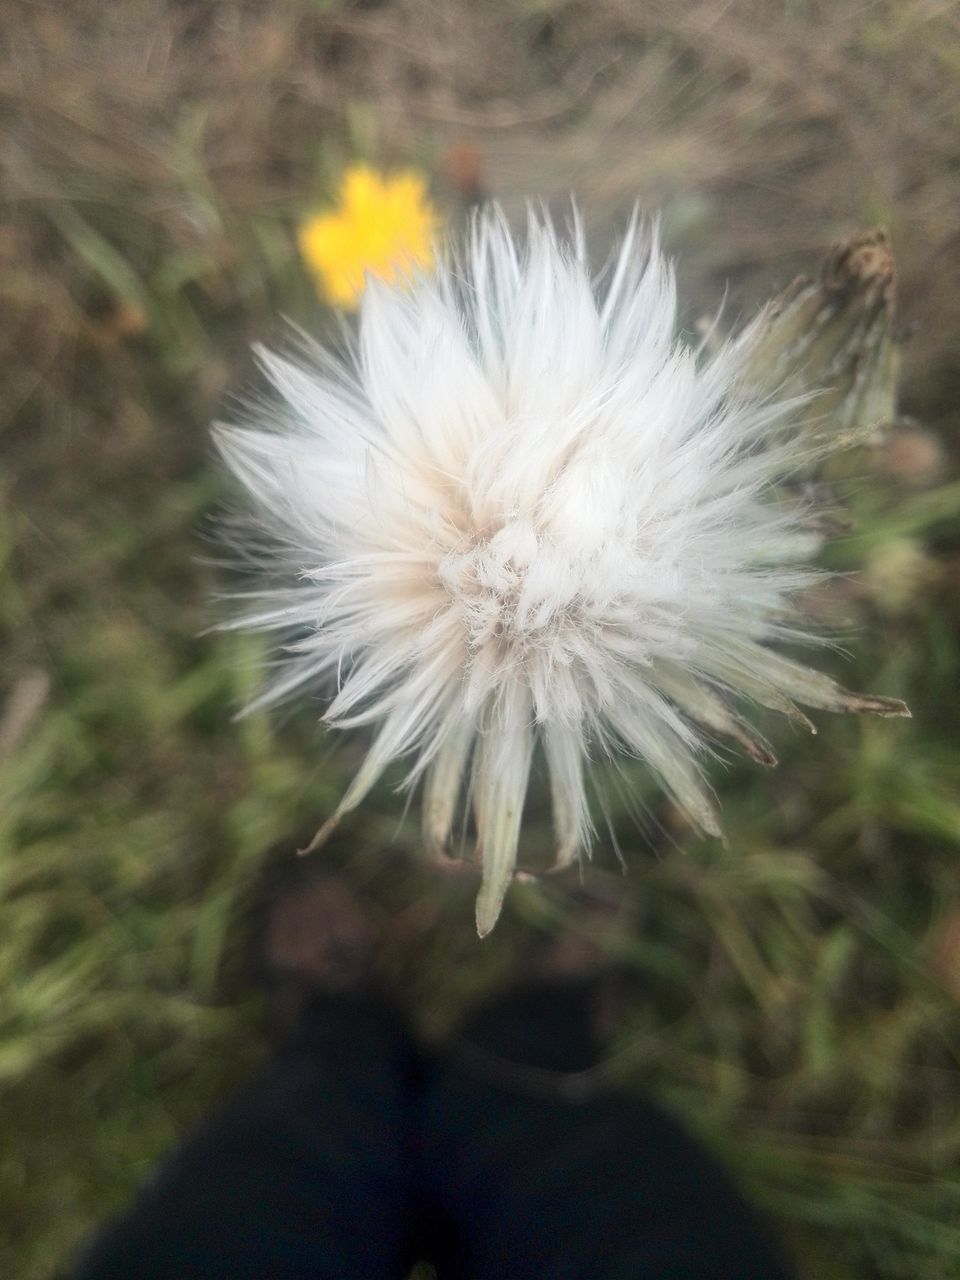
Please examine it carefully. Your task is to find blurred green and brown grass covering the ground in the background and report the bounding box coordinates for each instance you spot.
[0,0,960,1280]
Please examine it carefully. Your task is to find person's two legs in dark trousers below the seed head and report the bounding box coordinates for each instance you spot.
[72,860,787,1280]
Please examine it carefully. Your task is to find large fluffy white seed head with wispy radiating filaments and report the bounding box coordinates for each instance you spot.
[218,210,905,934]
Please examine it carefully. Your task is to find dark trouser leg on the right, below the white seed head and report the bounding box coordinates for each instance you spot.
[422,987,788,1280]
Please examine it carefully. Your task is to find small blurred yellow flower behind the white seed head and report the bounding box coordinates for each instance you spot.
[300,165,438,308]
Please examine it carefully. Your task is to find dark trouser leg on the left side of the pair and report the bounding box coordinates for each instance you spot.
[67,997,412,1280]
